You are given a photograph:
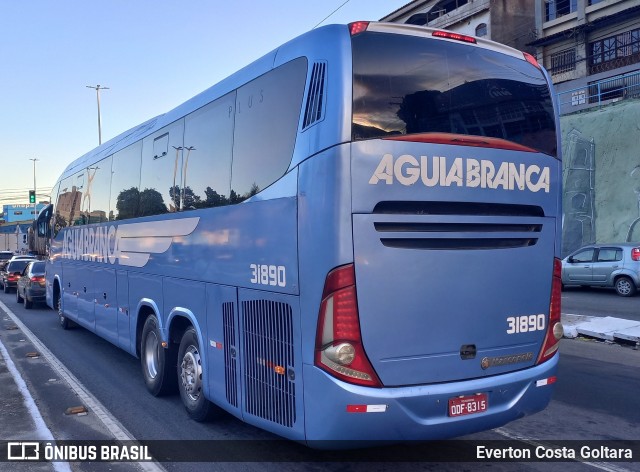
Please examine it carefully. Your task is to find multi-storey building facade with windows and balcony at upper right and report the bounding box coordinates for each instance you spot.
[530,0,640,114]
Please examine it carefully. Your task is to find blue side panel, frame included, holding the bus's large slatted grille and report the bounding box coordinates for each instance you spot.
[238,289,305,440]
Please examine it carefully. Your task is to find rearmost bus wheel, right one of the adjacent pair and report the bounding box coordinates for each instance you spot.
[178,327,217,421]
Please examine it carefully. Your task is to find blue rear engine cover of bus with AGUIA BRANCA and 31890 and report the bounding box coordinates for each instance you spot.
[352,141,561,386]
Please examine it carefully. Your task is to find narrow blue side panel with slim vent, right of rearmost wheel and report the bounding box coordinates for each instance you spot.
[206,284,242,418]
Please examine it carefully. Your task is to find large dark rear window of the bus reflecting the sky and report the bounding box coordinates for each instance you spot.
[352,32,557,156]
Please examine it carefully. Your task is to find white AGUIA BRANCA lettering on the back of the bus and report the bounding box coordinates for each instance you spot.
[369,154,550,193]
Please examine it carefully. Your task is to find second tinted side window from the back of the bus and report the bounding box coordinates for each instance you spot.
[180,93,235,211]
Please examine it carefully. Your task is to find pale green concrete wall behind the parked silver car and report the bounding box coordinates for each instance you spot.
[560,100,640,255]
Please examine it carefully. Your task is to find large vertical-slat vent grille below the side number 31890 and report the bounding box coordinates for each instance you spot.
[242,300,296,427]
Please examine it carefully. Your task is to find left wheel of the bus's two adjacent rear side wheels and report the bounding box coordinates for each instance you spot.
[140,315,176,396]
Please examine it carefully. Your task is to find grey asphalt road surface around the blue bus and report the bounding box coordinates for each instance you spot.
[0,291,640,472]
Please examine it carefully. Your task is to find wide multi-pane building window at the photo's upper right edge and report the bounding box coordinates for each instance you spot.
[589,29,640,74]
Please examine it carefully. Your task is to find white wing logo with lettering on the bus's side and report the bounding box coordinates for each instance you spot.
[61,217,200,267]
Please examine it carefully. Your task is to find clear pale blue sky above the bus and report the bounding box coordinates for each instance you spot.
[0,0,409,211]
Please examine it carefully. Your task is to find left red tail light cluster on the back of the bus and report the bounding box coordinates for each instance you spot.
[315,264,382,387]
